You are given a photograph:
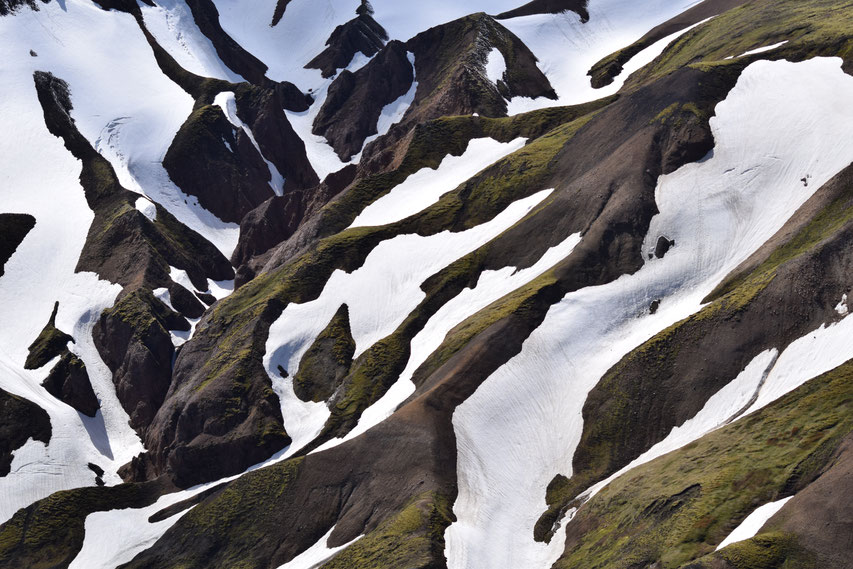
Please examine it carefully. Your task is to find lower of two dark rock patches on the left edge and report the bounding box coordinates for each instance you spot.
[0,389,51,477]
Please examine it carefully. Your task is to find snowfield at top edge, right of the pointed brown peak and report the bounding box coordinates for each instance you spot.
[501,0,712,115]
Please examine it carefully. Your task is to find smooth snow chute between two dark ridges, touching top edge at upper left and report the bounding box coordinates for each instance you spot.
[139,0,245,83]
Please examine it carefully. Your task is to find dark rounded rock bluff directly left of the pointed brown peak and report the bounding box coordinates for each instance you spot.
[313,40,414,160]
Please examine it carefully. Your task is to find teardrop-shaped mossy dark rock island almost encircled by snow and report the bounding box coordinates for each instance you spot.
[293,304,355,401]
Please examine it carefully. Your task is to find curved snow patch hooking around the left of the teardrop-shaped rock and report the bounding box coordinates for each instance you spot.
[264,190,552,449]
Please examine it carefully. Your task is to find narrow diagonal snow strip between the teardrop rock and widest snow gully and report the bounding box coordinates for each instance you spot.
[315,229,581,452]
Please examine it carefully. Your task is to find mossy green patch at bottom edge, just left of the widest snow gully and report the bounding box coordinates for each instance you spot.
[322,493,452,569]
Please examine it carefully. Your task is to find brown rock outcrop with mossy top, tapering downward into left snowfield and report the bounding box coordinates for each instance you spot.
[92,289,190,433]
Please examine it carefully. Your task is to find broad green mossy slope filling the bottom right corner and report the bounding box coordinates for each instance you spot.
[555,362,853,569]
